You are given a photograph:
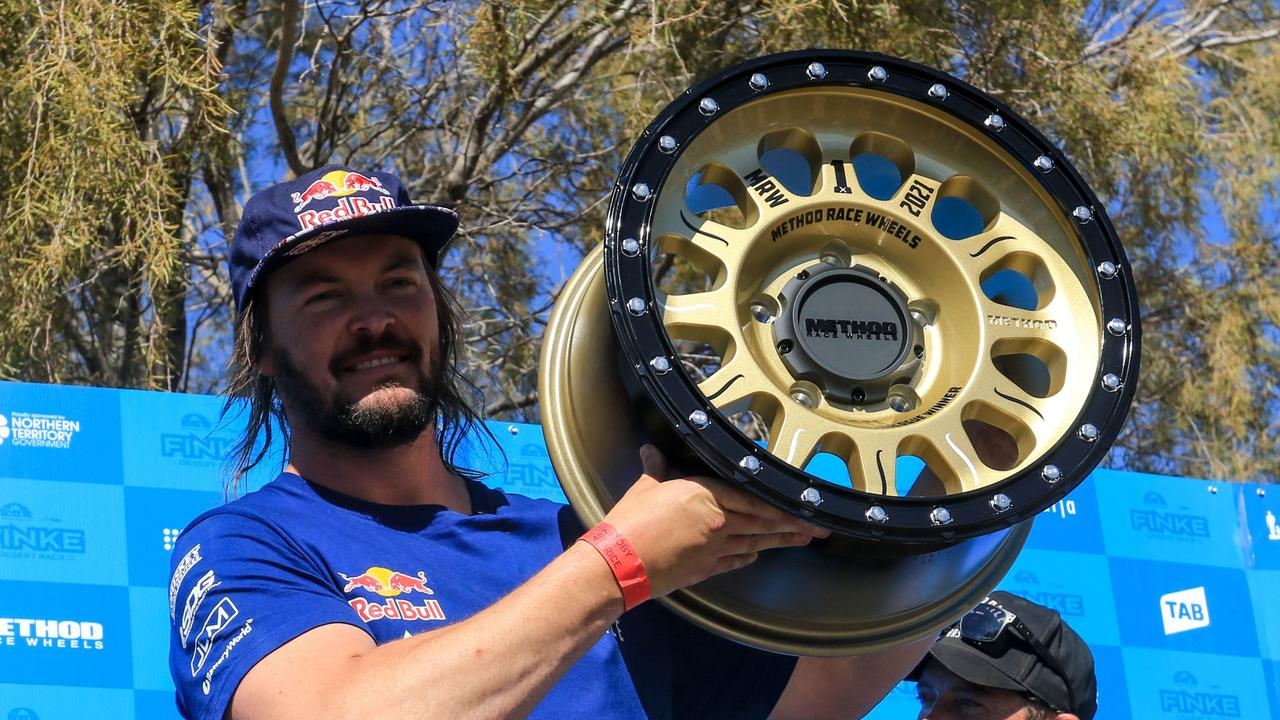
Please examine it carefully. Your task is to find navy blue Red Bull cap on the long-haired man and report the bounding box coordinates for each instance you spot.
[230,165,458,311]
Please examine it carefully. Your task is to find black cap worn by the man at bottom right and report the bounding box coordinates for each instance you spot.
[908,592,1098,720]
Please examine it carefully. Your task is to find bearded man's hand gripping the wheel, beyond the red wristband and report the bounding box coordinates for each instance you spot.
[604,445,831,597]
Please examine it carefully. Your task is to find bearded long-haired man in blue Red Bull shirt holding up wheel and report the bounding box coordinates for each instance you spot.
[169,167,927,719]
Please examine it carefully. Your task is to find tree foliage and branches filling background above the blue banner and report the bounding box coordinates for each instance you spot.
[0,0,1280,482]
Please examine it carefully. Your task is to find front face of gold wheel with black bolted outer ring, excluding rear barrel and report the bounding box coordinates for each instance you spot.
[605,51,1138,542]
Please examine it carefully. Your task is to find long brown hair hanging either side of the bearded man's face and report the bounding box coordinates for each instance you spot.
[219,255,497,497]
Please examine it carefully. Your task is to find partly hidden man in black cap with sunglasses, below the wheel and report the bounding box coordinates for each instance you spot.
[908,592,1098,720]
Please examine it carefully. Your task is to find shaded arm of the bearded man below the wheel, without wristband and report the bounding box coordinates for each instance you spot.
[769,635,934,720]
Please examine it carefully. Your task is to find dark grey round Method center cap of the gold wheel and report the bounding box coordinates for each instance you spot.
[774,264,915,404]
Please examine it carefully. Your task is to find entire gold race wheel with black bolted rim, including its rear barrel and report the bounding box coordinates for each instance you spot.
[539,50,1138,656]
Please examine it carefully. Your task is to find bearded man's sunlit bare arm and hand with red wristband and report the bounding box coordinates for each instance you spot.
[229,447,824,720]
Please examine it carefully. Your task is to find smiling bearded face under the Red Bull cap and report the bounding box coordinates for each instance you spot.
[260,236,442,448]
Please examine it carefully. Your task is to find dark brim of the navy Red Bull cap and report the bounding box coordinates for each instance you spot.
[248,199,458,288]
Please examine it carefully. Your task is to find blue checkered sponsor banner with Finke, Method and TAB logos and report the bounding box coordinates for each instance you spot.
[0,383,1280,720]
